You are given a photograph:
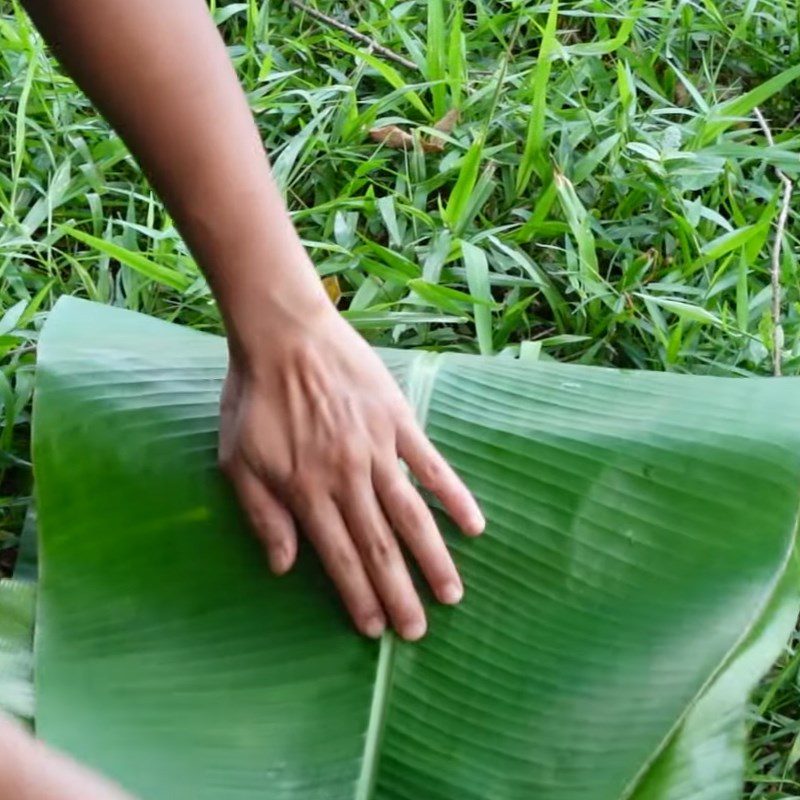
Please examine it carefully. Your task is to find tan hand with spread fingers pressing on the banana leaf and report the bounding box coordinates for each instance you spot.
[219,306,484,640]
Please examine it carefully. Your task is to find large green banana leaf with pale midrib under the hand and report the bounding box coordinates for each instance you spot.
[34,299,800,800]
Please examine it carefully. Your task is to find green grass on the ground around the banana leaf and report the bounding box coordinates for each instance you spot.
[0,0,800,800]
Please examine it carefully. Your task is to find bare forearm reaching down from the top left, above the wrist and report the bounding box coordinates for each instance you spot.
[25,0,326,356]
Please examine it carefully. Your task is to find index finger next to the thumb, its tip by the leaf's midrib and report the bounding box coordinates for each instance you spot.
[299,495,386,638]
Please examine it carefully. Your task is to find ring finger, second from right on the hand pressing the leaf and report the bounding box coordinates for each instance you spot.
[374,460,464,604]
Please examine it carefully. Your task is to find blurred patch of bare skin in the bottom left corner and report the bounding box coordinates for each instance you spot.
[0,715,131,800]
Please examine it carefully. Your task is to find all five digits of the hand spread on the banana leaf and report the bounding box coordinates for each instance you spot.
[224,406,478,640]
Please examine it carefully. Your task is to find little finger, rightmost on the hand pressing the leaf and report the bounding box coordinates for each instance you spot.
[397,421,486,536]
